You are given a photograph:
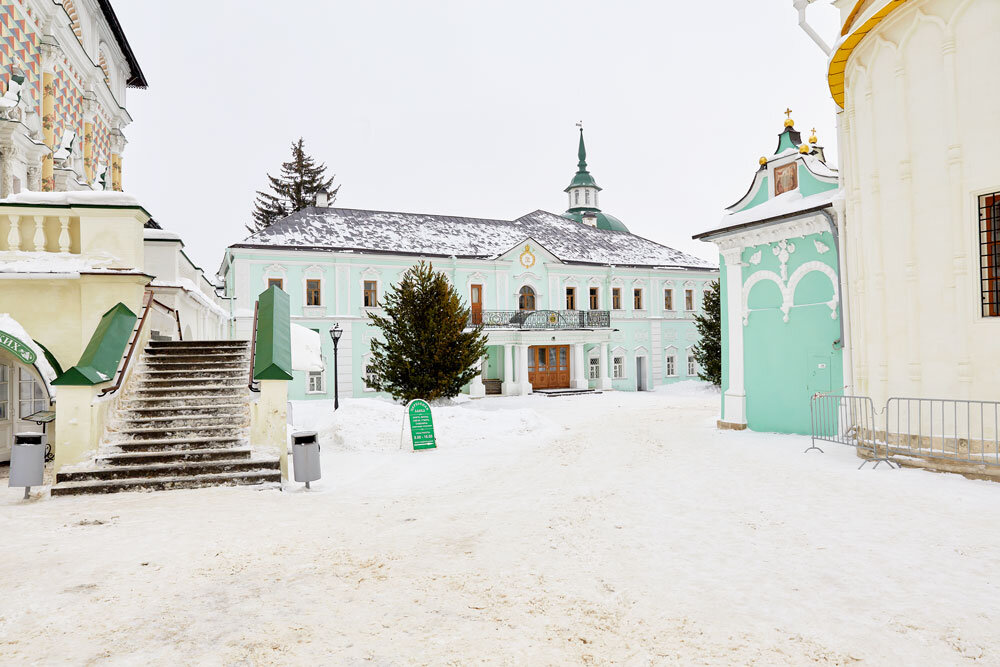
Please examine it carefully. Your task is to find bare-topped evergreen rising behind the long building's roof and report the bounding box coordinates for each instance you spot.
[247,137,340,233]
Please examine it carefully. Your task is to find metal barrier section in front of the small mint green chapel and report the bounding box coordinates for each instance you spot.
[805,394,893,469]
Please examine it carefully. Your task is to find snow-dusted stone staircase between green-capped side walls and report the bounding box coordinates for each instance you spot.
[52,340,281,496]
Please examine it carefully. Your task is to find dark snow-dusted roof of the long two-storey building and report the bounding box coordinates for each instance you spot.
[233,207,714,269]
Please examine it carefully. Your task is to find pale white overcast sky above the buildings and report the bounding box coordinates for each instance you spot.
[113,0,836,273]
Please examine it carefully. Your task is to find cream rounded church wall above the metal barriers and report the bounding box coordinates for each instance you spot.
[841,0,1000,405]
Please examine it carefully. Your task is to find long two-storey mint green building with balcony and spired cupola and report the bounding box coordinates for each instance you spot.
[220,130,718,400]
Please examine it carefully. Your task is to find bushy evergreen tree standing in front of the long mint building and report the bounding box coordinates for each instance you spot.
[368,262,486,401]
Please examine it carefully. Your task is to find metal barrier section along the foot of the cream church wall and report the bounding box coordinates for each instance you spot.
[882,398,1000,466]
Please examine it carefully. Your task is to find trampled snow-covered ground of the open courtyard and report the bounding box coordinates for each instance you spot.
[0,384,1000,665]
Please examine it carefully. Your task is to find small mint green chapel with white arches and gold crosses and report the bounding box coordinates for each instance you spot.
[695,119,845,434]
